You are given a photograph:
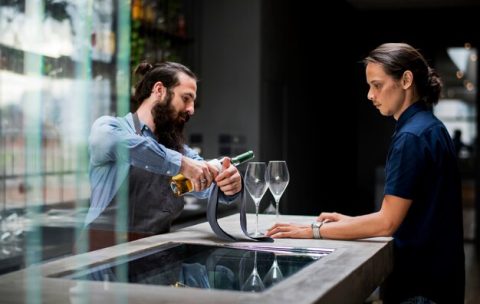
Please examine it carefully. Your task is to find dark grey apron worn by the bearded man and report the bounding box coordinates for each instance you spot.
[84,113,184,250]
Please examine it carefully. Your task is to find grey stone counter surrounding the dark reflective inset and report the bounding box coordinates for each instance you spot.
[0,214,393,304]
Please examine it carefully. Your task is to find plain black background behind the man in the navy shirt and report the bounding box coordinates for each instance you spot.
[261,0,479,230]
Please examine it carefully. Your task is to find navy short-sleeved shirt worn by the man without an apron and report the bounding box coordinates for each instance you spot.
[384,102,465,303]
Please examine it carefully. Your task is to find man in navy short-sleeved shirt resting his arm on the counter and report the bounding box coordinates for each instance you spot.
[267,43,465,304]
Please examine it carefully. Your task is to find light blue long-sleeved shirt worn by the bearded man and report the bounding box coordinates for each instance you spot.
[85,113,238,225]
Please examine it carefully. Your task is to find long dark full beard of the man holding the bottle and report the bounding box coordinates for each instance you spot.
[152,90,190,153]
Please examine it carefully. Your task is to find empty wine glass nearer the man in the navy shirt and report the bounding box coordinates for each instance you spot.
[265,160,290,222]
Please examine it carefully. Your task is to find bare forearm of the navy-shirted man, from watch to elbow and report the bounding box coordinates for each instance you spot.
[320,212,393,240]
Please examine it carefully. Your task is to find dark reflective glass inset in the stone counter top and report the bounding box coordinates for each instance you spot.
[59,243,332,292]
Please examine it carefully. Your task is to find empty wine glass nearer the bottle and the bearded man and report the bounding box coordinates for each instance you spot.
[245,162,268,237]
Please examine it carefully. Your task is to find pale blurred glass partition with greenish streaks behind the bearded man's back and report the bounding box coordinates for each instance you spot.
[0,0,130,278]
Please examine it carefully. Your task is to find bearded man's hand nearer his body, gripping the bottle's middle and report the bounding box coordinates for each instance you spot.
[180,156,214,191]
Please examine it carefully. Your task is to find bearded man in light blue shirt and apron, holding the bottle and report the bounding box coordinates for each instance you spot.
[81,62,242,250]
